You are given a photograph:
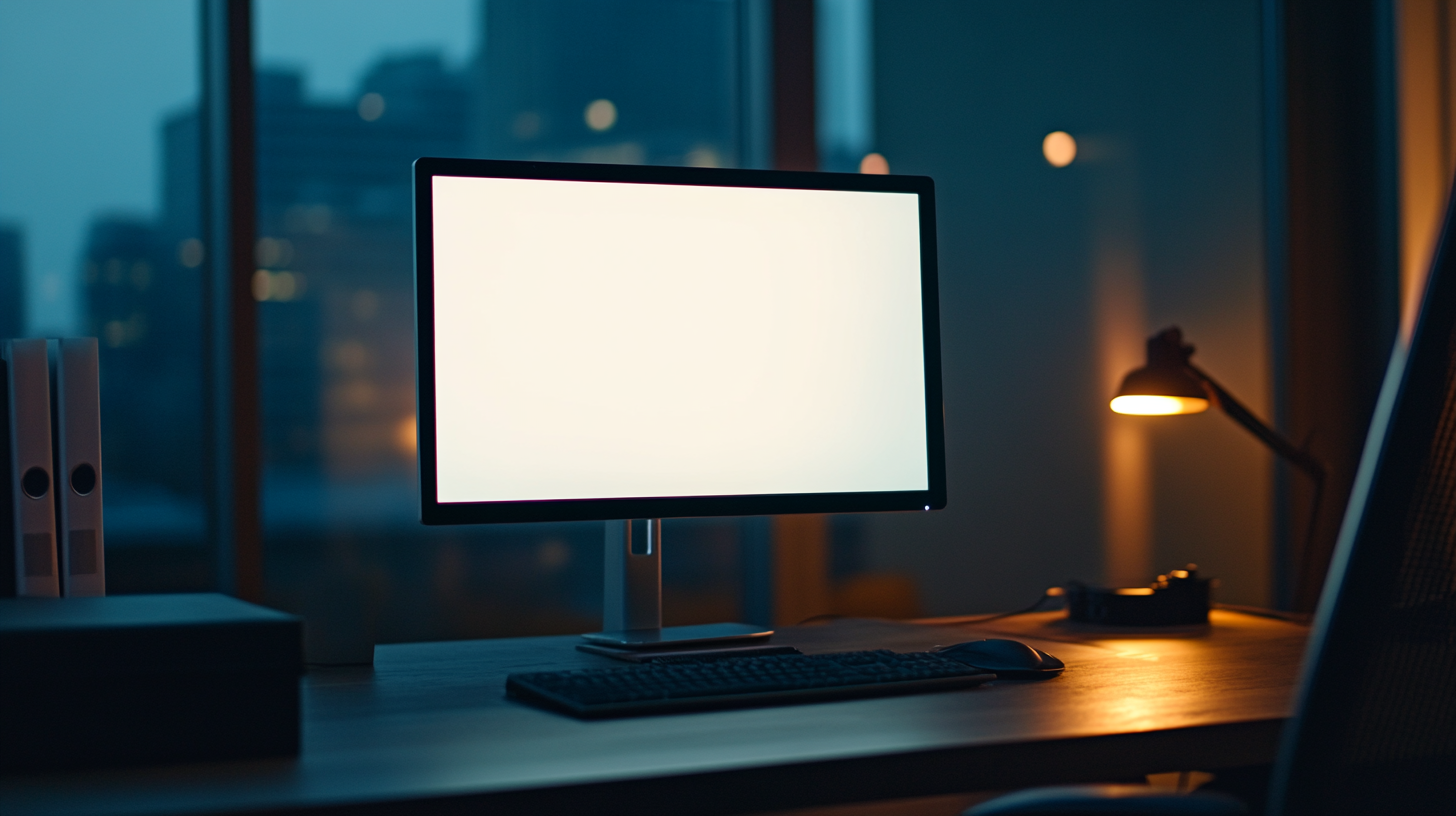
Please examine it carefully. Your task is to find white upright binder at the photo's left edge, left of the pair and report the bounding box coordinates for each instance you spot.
[0,340,61,597]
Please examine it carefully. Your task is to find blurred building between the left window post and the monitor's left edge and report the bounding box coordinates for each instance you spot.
[253,54,469,479]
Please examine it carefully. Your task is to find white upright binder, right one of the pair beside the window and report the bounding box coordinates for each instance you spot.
[50,337,106,597]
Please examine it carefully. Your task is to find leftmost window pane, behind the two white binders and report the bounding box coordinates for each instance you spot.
[0,0,213,592]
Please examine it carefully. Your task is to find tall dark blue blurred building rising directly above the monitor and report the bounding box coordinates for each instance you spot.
[473,0,745,168]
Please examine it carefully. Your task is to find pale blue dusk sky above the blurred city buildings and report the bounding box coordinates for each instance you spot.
[0,0,478,335]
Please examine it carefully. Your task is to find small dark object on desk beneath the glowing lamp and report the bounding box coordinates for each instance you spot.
[1066,564,1214,627]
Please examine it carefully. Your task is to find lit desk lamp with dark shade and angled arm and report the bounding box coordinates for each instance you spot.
[1112,326,1325,603]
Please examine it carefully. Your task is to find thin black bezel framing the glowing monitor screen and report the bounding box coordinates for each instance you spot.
[414,157,945,525]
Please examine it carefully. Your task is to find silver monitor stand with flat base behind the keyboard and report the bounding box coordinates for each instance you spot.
[581,519,773,651]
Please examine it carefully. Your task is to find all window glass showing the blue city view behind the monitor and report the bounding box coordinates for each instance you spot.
[0,0,891,643]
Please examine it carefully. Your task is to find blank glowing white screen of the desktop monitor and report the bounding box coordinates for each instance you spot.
[432,176,929,503]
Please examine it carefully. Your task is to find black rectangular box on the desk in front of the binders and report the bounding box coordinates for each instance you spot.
[0,595,303,772]
